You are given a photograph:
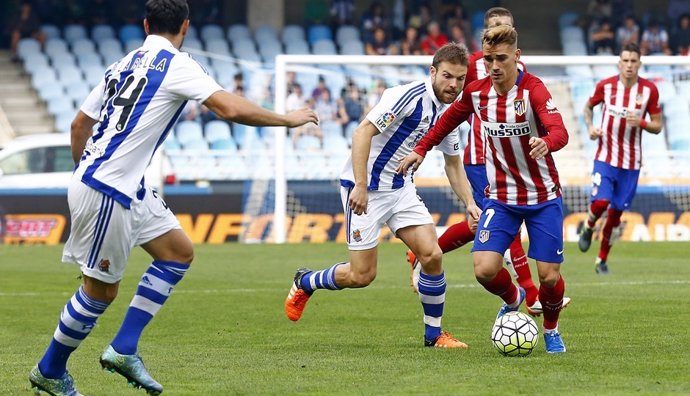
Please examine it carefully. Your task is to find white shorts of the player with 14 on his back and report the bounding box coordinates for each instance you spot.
[62,180,182,283]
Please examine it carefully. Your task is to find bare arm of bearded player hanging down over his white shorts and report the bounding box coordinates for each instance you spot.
[348,118,379,215]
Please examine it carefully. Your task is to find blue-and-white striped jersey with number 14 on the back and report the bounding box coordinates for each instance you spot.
[74,35,223,208]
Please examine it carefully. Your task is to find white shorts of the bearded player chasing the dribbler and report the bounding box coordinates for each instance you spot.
[340,183,434,250]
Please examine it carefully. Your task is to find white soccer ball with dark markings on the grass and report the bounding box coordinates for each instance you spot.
[491,311,539,356]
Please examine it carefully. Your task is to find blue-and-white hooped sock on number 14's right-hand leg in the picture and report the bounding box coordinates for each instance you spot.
[110,260,189,355]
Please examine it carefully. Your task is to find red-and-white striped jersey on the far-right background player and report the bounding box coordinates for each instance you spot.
[589,76,661,169]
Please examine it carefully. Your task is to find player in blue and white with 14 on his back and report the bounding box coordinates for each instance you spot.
[29,0,318,395]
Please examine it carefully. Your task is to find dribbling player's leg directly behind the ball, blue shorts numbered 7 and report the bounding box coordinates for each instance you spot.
[472,199,525,317]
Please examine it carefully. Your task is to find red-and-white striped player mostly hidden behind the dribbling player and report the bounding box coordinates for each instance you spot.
[407,7,548,316]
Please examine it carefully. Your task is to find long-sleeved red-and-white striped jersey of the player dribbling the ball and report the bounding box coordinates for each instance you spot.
[415,71,568,205]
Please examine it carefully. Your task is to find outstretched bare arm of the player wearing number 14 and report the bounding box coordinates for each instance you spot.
[203,90,319,128]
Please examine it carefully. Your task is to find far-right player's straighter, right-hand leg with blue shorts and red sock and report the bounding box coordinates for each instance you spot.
[594,169,640,275]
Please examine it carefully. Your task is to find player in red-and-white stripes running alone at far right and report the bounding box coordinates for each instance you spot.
[578,44,663,274]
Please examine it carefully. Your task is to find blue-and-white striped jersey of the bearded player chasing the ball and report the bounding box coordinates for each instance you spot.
[340,78,460,191]
